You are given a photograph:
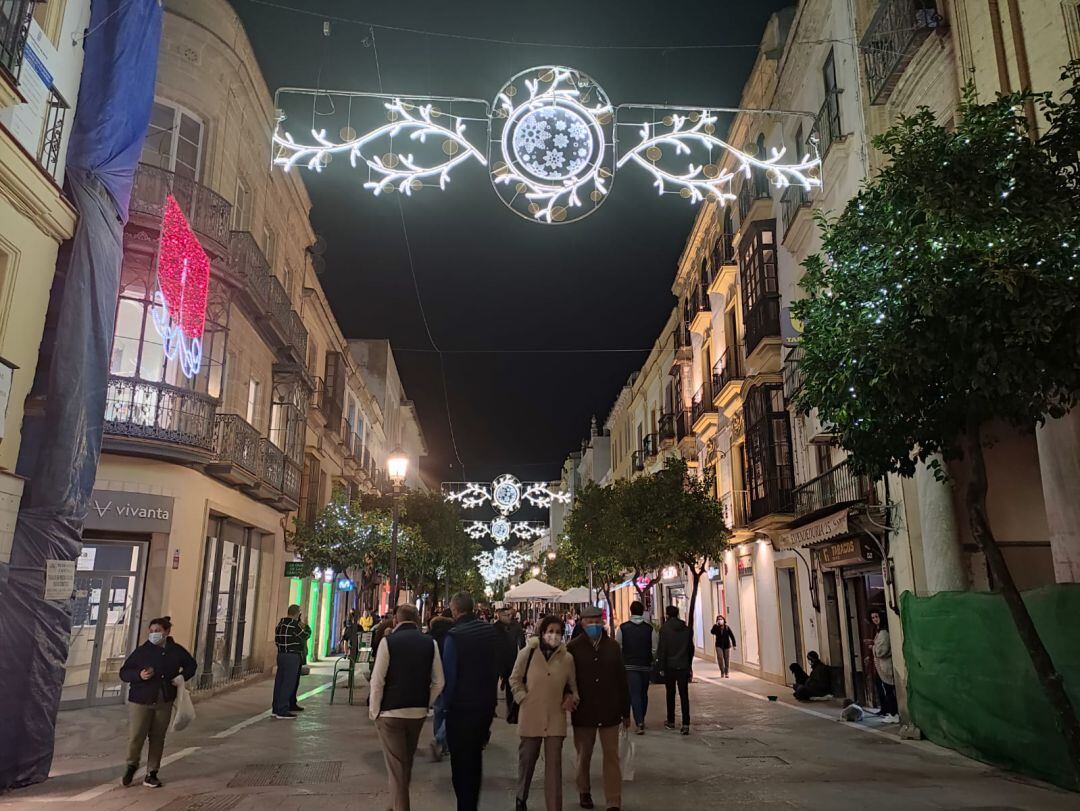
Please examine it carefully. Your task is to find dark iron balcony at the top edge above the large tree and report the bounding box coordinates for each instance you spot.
[860,0,943,105]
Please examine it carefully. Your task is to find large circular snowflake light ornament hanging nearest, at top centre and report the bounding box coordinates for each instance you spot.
[488,65,615,224]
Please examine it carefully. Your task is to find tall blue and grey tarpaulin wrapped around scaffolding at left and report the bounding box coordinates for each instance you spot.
[0,0,162,790]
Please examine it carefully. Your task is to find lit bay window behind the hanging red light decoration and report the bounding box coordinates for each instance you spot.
[109,252,229,397]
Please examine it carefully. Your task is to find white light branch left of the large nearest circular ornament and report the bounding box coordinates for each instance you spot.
[273,98,487,195]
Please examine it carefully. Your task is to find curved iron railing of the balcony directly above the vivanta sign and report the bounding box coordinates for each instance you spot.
[105,375,217,451]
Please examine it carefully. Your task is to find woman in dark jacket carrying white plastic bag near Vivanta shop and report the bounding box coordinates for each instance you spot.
[120,617,199,788]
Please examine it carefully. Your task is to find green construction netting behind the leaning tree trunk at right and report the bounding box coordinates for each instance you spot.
[900,584,1080,788]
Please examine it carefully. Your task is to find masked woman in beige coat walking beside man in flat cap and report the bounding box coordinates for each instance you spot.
[510,617,578,811]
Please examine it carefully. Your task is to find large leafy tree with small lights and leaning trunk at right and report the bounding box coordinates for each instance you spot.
[792,72,1080,780]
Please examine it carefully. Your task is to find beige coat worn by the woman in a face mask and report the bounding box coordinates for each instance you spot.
[510,636,578,738]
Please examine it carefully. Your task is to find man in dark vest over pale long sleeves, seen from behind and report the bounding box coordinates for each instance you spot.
[368,605,444,811]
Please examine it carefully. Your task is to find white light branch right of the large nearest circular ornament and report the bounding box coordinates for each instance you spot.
[618,109,821,205]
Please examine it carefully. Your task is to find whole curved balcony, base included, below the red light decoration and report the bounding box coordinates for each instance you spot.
[104,376,217,461]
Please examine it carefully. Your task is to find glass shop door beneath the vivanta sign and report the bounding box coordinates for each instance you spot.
[60,541,146,709]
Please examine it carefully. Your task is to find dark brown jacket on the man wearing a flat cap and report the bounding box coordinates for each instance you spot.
[566,632,630,727]
